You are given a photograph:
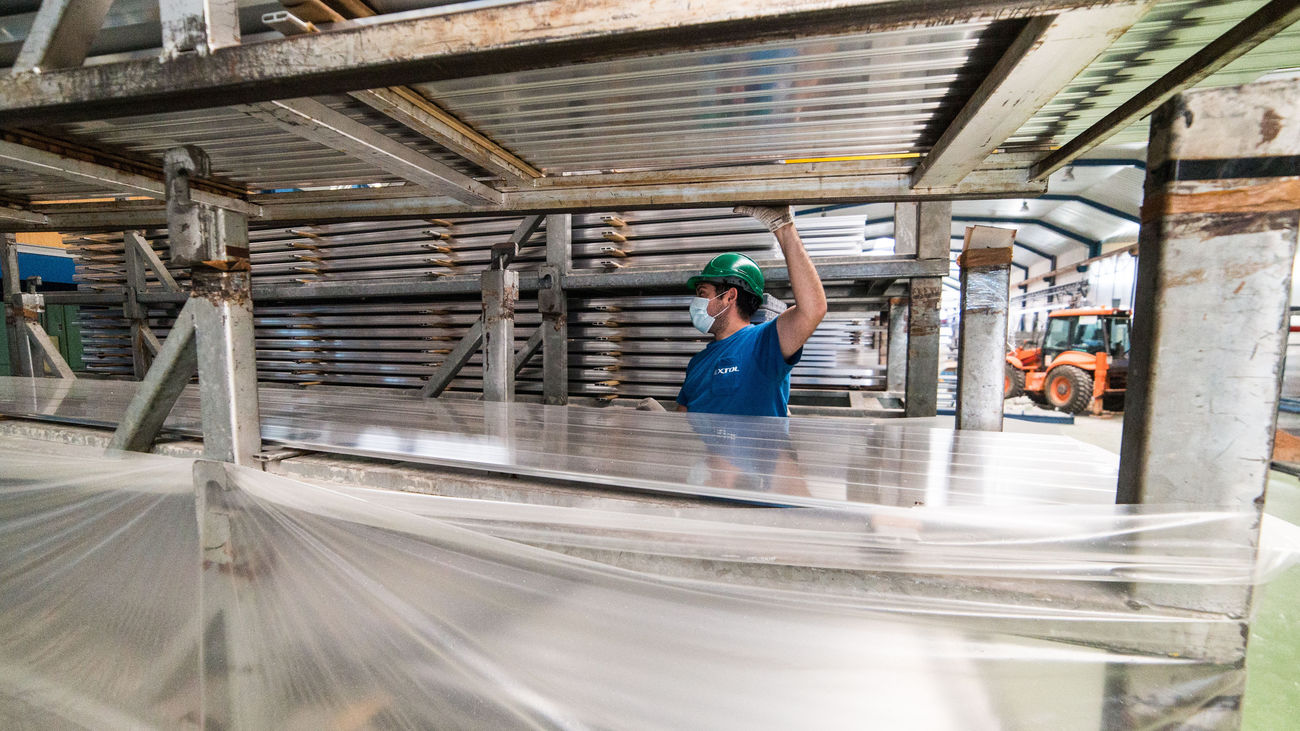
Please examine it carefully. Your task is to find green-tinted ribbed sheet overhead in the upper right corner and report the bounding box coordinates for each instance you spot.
[1006,0,1300,148]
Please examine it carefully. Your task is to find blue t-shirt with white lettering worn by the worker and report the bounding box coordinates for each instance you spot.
[677,320,803,416]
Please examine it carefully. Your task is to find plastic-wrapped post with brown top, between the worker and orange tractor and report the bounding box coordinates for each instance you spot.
[957,226,1015,432]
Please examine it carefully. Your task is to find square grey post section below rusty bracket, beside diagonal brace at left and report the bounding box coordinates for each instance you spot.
[190,260,261,464]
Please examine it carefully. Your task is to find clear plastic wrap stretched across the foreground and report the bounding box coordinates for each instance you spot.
[0,438,1297,731]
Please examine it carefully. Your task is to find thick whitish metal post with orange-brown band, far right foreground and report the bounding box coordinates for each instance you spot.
[1109,81,1300,728]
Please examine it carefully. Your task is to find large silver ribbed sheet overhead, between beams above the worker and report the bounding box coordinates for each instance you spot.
[419,23,1015,173]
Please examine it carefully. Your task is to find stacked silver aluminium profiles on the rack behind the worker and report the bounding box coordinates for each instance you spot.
[68,209,884,399]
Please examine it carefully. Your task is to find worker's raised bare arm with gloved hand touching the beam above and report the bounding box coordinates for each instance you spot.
[735,206,826,358]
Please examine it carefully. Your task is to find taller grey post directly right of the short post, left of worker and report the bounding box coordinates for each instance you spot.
[537,213,573,406]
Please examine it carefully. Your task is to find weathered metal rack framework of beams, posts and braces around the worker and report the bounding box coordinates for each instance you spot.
[0,0,1300,722]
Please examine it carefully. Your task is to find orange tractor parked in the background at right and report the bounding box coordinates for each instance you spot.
[1002,307,1128,414]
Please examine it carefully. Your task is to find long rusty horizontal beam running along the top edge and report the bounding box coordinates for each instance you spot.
[0,0,1154,125]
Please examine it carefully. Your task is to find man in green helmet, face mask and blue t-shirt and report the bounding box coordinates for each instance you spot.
[677,206,826,416]
